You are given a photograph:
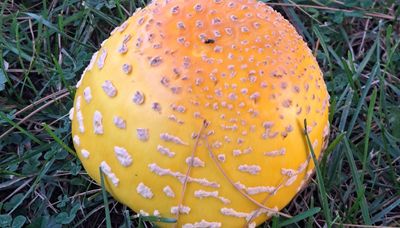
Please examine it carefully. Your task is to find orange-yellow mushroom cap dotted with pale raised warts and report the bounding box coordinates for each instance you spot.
[70,0,329,227]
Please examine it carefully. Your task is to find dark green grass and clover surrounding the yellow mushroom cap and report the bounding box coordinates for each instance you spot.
[0,0,400,227]
